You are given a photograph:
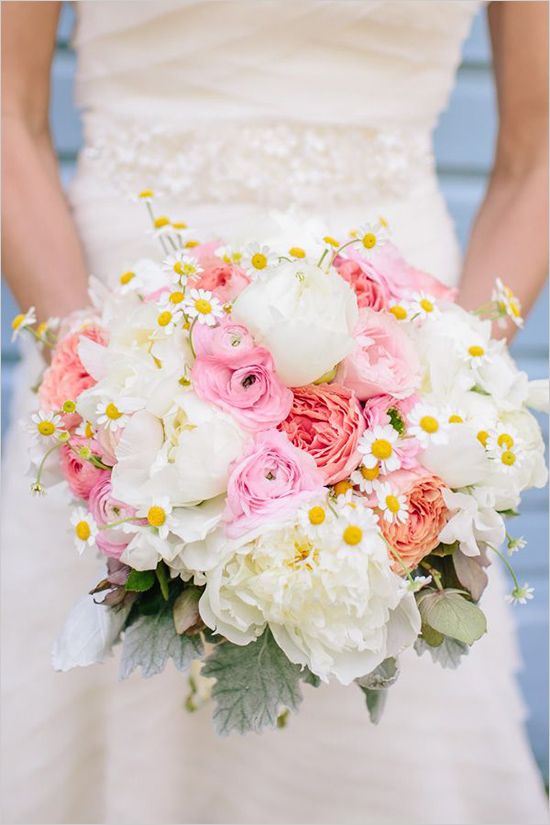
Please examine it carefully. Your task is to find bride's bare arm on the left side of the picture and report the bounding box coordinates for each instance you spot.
[2,2,87,320]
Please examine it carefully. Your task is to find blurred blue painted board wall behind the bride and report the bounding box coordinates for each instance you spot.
[2,4,548,778]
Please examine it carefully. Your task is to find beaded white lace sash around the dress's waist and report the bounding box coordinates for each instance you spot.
[81,121,434,209]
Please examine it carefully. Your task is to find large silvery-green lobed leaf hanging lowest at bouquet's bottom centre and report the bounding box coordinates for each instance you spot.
[202,628,302,736]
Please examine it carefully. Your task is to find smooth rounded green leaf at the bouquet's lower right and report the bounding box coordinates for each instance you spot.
[417,590,487,645]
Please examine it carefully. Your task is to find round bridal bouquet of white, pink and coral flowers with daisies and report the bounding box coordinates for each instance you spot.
[14,192,546,734]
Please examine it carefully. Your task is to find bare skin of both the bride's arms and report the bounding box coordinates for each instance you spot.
[1,0,548,336]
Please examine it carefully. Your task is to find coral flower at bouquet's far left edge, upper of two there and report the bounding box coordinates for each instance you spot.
[38,324,107,429]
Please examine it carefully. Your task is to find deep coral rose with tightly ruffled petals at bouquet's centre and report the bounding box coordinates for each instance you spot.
[279,384,365,484]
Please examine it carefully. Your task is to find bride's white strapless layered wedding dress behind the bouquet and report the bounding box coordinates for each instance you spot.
[2,0,547,825]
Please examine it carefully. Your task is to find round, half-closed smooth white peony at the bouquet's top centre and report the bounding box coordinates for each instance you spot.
[232,261,358,387]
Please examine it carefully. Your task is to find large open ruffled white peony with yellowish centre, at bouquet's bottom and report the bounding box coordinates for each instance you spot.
[199,525,420,685]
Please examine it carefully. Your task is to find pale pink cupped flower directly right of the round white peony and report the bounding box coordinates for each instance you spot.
[336,309,420,401]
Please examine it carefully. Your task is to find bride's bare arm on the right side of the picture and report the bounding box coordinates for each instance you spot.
[459,2,548,334]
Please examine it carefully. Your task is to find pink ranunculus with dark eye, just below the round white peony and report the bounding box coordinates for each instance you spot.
[191,347,292,432]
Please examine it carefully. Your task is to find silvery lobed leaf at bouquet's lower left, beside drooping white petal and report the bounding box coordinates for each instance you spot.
[120,608,203,679]
